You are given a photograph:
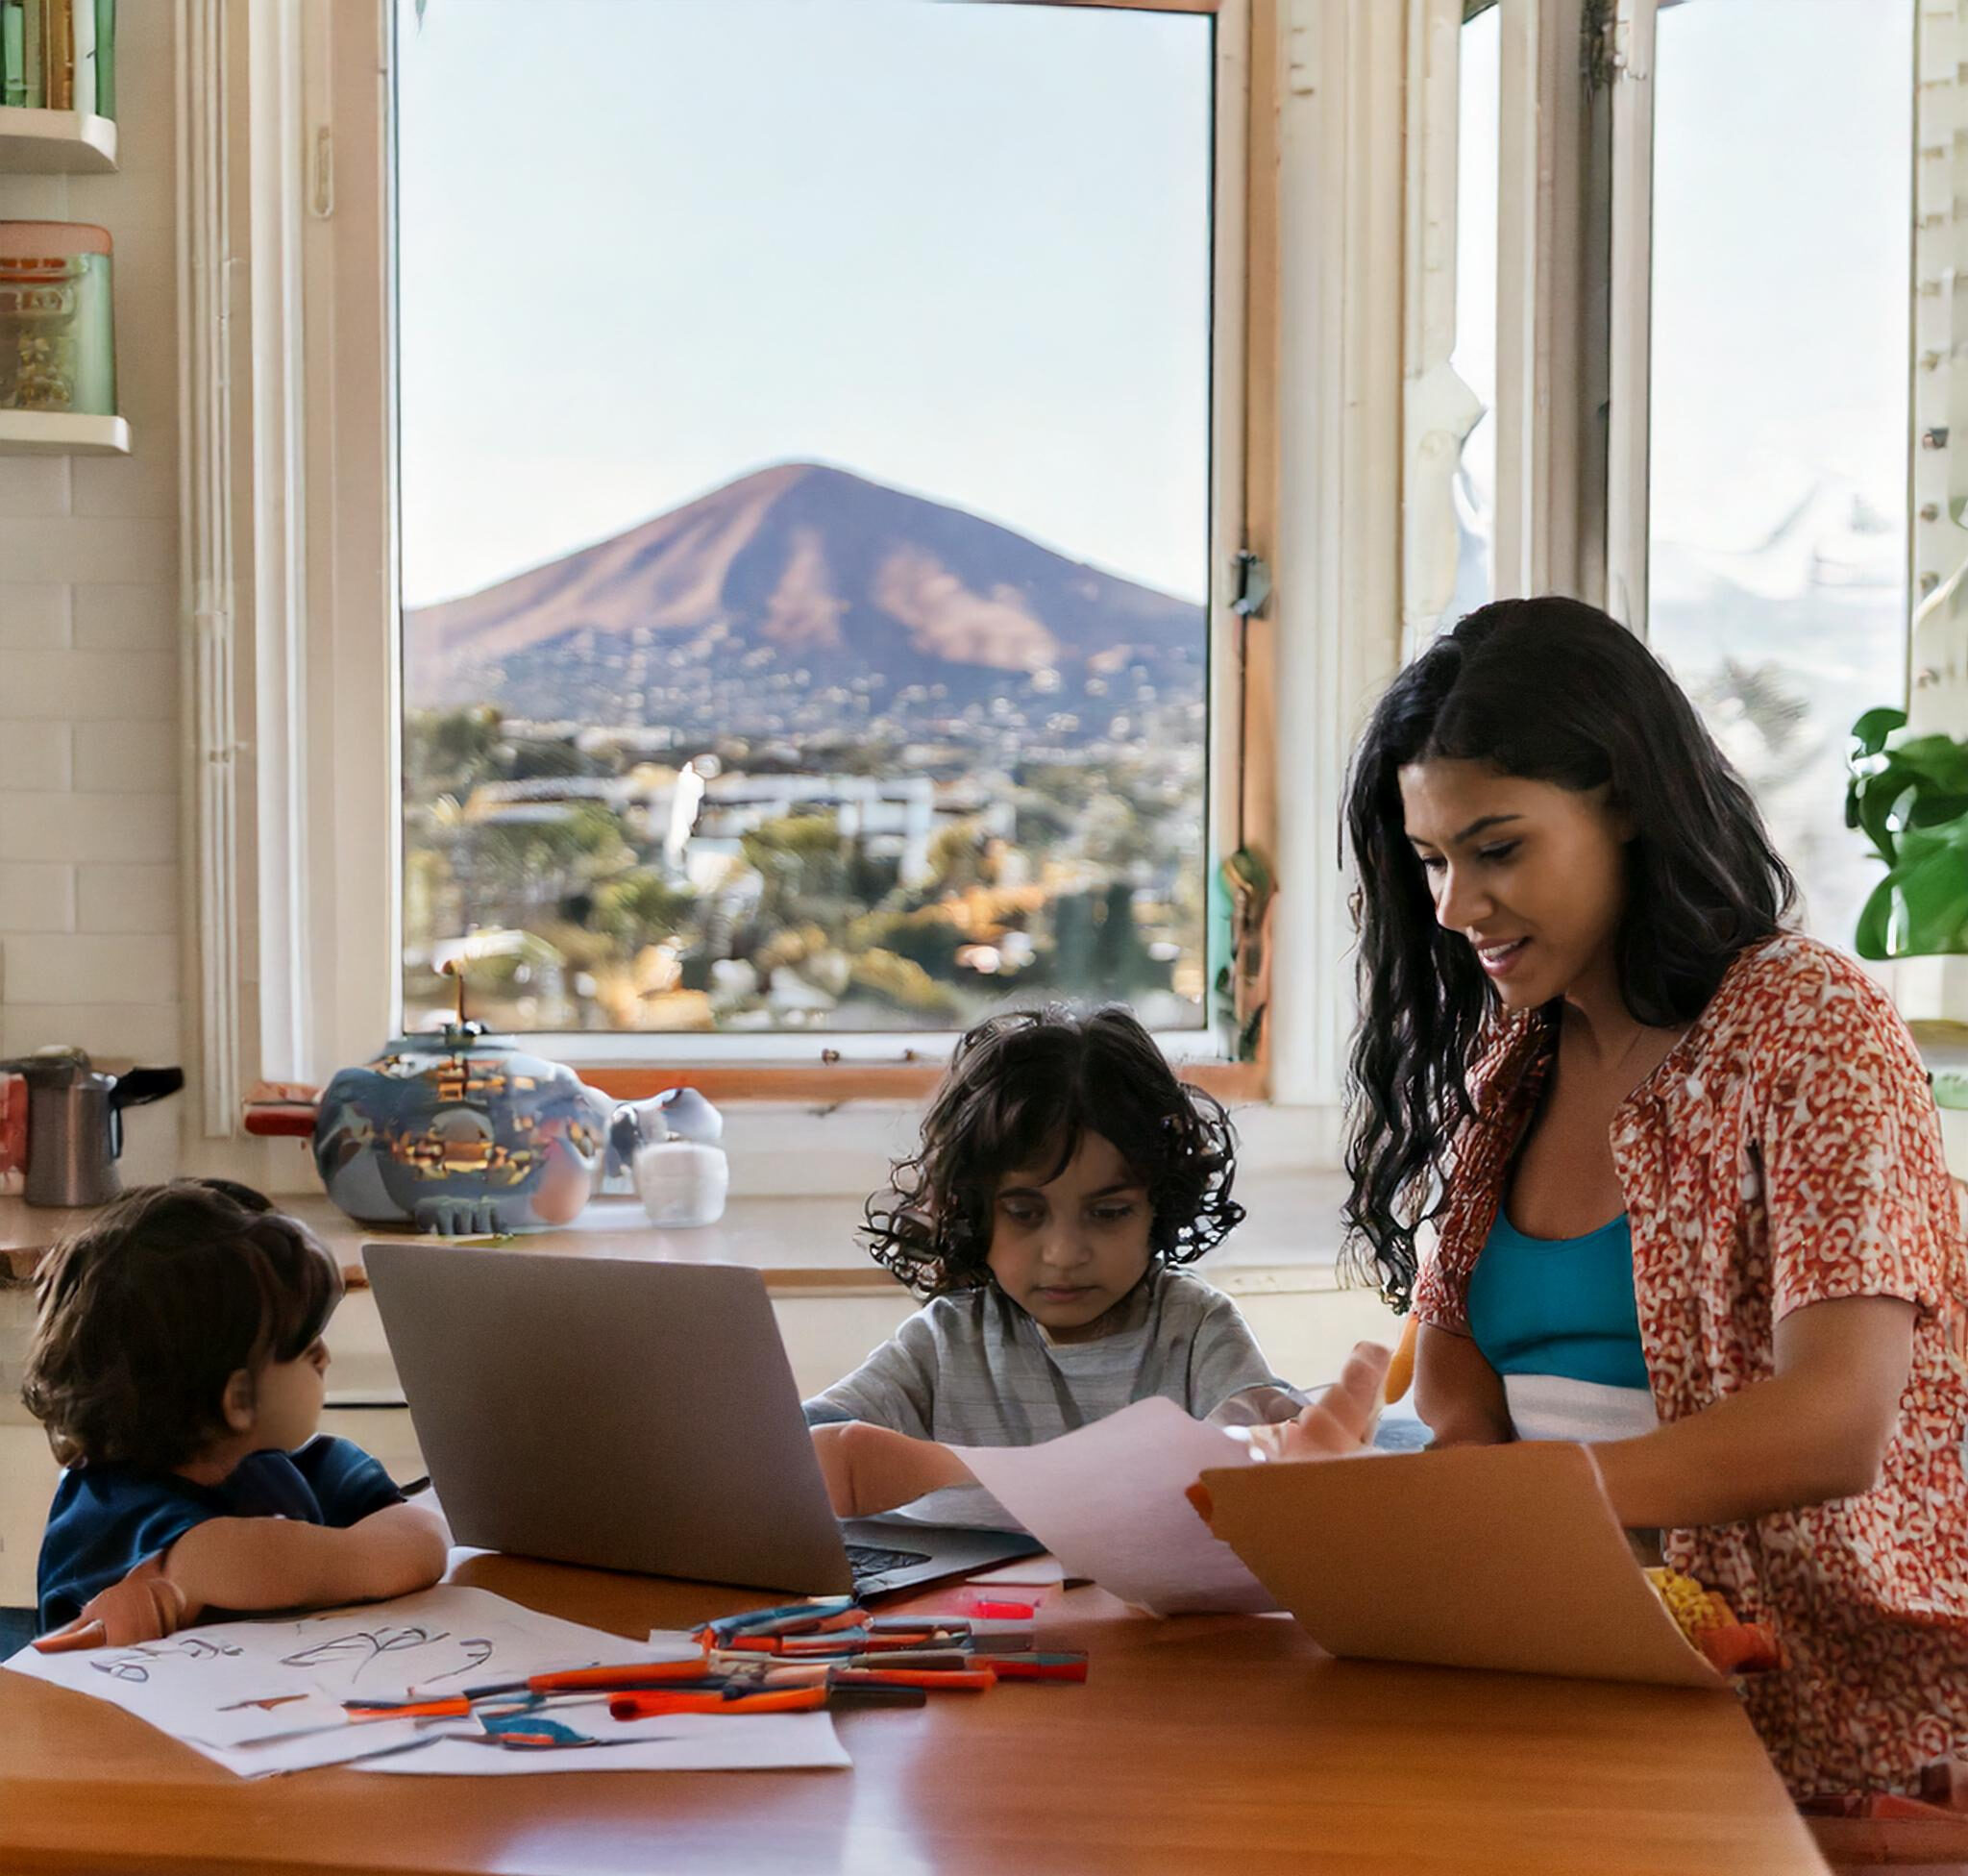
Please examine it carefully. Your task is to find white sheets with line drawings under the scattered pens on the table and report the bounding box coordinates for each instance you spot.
[6,1585,845,1778]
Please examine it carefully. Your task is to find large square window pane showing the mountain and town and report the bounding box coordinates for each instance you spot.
[398,0,1215,1031]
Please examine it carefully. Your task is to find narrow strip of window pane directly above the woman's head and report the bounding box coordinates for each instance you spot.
[1442,6,1504,624]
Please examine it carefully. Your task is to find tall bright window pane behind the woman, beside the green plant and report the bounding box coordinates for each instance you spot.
[1647,0,1913,947]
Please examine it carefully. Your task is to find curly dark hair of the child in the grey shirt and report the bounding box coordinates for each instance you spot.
[862,1006,1243,1297]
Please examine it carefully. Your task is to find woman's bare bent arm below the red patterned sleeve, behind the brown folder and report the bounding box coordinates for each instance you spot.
[1592,1296,1915,1530]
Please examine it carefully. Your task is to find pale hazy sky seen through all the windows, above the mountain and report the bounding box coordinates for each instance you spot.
[400,0,1913,605]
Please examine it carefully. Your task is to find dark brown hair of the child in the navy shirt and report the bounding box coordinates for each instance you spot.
[19,1179,342,1472]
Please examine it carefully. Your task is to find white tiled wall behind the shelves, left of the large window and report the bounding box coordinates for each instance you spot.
[0,4,183,1177]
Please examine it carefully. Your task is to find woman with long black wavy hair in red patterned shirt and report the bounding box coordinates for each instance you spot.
[1299,599,1968,1797]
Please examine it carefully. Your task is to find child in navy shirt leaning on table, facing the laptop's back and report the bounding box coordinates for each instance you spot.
[22,1179,447,1647]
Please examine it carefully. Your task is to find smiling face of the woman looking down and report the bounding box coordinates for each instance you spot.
[1401,760,1634,1010]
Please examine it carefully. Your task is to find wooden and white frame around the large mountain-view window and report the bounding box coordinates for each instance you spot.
[203,0,1407,1141]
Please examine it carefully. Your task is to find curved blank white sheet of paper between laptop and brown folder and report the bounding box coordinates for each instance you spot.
[952,1395,1277,1617]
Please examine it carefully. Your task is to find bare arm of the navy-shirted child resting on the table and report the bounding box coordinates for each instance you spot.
[37,1504,449,1654]
